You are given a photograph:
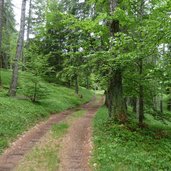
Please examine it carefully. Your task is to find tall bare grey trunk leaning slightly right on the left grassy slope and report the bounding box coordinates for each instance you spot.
[8,0,26,96]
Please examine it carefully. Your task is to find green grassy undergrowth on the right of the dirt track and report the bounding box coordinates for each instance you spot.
[92,107,171,171]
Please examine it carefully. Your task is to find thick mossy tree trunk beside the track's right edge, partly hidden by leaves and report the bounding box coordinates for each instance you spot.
[108,0,127,122]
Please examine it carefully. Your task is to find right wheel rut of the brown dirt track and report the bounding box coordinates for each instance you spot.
[59,97,102,171]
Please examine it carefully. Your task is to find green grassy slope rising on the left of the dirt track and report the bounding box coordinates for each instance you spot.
[0,71,93,152]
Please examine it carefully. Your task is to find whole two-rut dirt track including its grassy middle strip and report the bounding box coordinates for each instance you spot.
[0,95,102,171]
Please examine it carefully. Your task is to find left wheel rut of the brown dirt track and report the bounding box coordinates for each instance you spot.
[0,100,97,171]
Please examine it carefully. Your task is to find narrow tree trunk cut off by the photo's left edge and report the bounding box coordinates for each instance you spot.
[0,0,4,86]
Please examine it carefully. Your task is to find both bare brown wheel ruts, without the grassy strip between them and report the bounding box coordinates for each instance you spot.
[0,99,102,171]
